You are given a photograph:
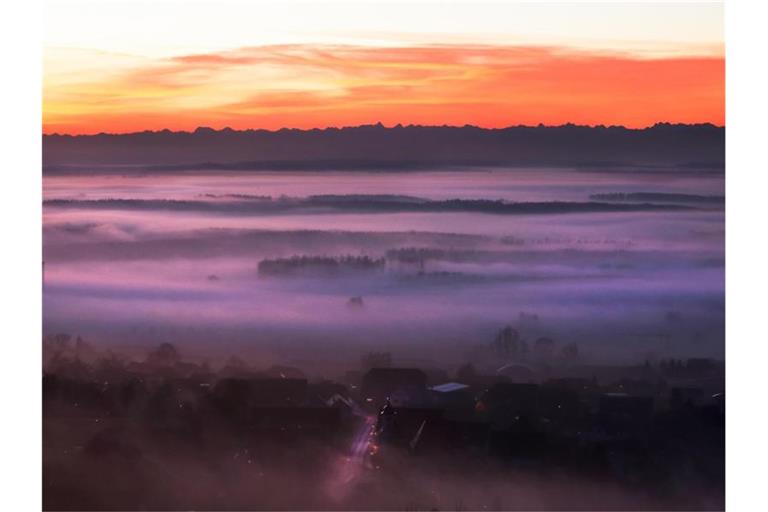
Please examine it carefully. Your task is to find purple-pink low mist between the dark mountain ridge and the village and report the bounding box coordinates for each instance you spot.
[43,169,724,366]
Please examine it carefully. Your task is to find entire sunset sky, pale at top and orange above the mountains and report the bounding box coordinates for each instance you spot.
[43,0,725,134]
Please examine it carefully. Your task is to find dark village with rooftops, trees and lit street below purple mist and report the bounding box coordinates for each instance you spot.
[43,331,725,508]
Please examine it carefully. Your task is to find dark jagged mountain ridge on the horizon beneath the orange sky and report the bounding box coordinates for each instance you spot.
[43,123,725,171]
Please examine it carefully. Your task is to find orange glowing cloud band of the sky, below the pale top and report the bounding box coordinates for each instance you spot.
[43,45,725,133]
